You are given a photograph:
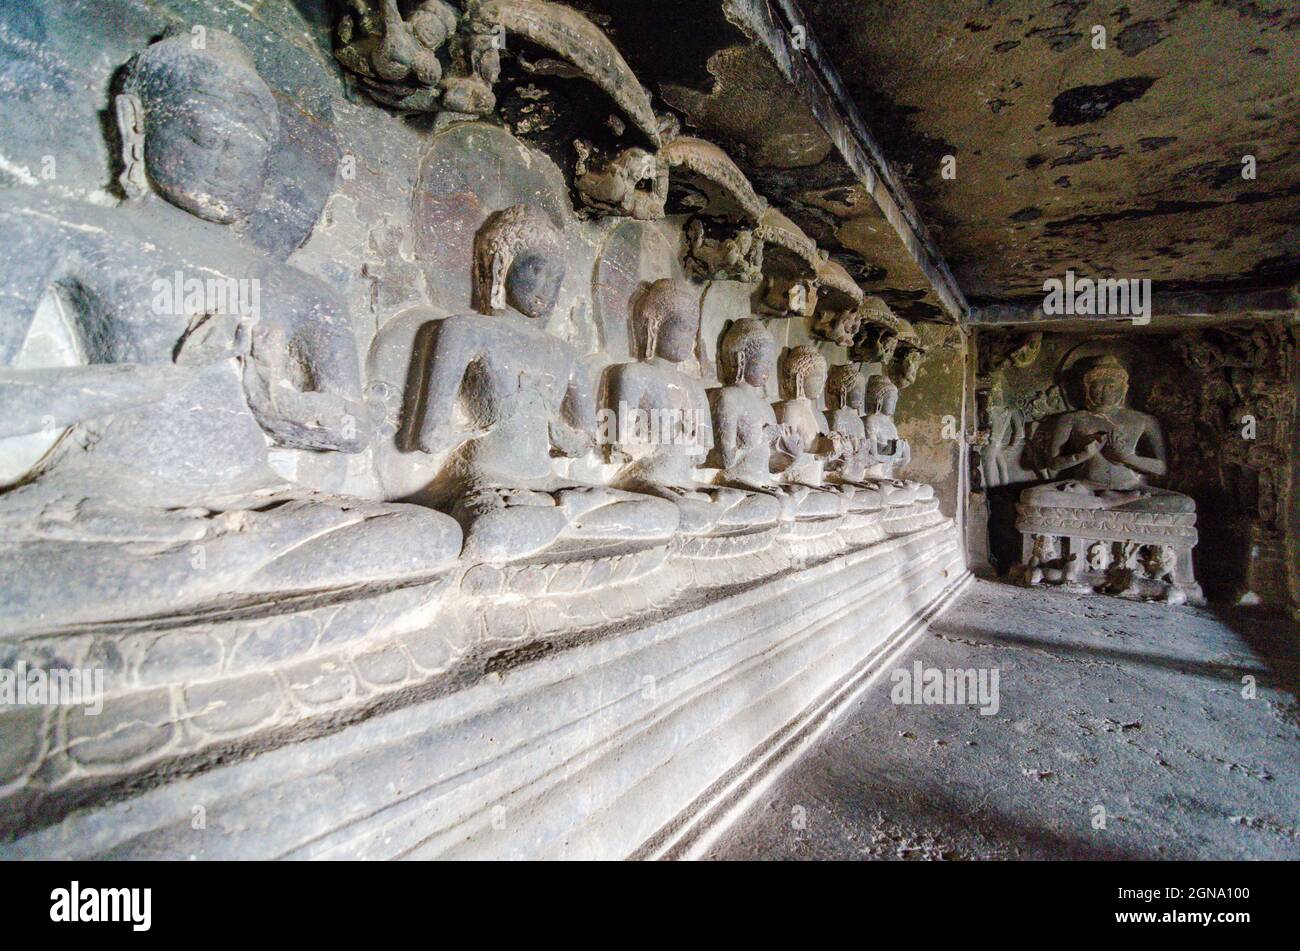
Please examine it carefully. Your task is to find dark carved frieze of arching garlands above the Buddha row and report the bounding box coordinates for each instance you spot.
[334,0,926,368]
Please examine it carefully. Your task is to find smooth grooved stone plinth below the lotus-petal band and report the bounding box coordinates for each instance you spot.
[0,524,965,857]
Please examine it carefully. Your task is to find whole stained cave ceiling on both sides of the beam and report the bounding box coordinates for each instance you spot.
[585,0,1300,320]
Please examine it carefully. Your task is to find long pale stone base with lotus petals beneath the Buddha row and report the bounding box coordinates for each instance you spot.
[0,504,965,857]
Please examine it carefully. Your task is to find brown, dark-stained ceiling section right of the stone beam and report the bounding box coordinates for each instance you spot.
[803,0,1300,303]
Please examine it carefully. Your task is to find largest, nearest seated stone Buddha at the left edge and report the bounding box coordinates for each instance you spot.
[0,30,460,624]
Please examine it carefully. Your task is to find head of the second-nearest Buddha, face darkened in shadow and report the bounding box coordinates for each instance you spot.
[473,205,564,318]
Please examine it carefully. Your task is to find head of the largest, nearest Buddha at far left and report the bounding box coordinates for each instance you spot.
[116,30,280,223]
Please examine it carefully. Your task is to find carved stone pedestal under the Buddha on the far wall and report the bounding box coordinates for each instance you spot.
[1011,503,1205,604]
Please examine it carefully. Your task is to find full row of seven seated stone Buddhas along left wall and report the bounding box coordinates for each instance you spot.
[0,30,931,626]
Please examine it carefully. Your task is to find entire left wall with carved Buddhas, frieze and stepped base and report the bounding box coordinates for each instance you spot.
[0,0,966,855]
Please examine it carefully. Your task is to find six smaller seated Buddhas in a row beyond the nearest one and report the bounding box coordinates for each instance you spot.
[407,205,932,560]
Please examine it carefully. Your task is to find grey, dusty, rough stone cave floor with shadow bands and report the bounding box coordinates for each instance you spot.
[710,581,1300,859]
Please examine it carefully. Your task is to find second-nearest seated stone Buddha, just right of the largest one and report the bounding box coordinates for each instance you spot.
[415,205,680,561]
